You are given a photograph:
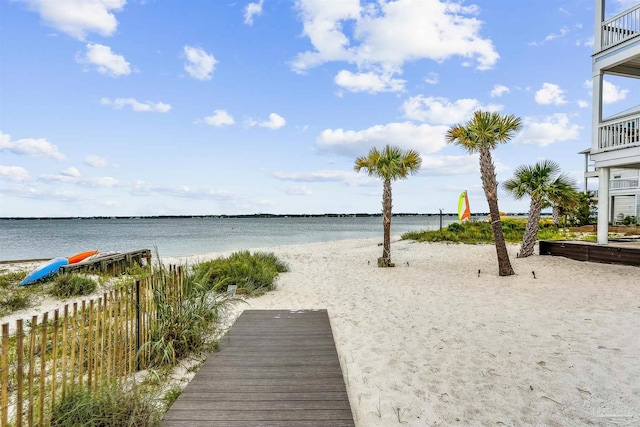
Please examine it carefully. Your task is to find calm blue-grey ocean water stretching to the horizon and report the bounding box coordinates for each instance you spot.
[0,215,457,261]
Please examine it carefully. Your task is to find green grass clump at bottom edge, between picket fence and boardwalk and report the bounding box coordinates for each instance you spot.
[51,384,160,427]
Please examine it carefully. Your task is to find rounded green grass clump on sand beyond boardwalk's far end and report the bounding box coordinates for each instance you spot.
[195,251,289,296]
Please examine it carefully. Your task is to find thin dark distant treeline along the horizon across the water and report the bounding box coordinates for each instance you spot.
[0,212,527,221]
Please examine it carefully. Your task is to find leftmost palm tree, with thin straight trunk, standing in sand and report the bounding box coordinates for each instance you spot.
[353,145,422,267]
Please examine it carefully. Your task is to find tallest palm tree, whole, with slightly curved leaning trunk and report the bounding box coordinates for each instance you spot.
[445,111,522,276]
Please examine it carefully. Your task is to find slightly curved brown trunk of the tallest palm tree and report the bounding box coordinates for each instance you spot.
[480,148,515,276]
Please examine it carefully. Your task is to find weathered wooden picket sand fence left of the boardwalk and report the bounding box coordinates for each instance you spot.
[0,267,183,427]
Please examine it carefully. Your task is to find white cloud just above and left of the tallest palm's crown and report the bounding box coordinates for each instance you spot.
[402,95,502,125]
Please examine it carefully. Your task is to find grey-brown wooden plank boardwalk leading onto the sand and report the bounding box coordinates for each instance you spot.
[161,310,354,427]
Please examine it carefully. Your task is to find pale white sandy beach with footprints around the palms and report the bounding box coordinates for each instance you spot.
[2,237,640,427]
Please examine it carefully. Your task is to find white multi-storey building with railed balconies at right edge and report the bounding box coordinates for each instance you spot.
[590,0,640,244]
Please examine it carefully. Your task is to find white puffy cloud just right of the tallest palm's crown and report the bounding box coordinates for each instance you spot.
[514,113,581,147]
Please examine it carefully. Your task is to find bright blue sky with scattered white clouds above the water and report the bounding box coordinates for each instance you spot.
[0,0,640,217]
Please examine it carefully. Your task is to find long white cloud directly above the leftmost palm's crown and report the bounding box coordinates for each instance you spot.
[316,122,448,157]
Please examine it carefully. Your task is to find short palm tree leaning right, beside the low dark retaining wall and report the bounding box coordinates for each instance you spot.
[503,160,577,258]
